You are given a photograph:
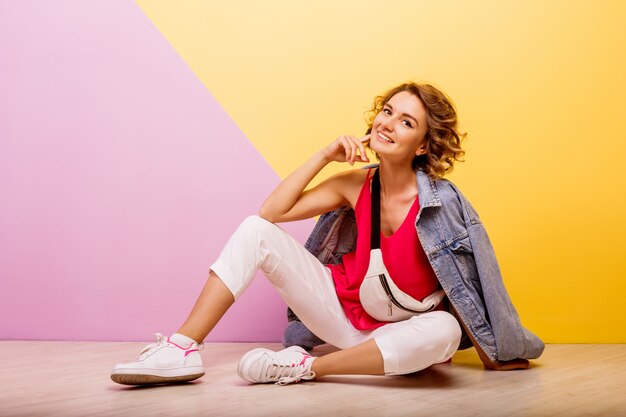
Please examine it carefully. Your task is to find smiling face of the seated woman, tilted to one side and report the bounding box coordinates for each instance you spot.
[370,91,428,161]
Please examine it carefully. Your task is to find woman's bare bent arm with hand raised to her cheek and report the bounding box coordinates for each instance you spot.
[259,135,369,223]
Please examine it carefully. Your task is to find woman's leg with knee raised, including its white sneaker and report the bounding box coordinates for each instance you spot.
[111,216,360,385]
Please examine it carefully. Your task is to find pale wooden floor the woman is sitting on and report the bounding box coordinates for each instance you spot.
[0,341,626,417]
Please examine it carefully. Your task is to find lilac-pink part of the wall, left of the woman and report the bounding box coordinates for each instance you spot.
[0,1,313,341]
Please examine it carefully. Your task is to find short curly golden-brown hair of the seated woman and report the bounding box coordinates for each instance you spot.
[365,82,467,179]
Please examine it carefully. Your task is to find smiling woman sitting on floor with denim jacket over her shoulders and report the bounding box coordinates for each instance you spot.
[111,79,543,385]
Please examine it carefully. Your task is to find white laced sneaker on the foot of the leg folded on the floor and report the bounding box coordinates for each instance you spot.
[237,346,315,385]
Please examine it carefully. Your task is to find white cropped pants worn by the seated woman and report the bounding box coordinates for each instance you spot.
[210,216,461,375]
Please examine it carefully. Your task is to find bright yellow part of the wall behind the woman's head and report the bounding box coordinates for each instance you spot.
[137,0,626,343]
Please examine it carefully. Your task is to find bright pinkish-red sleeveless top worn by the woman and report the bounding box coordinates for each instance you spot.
[326,169,439,330]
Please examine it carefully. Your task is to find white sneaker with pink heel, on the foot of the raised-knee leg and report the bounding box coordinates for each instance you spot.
[111,333,204,385]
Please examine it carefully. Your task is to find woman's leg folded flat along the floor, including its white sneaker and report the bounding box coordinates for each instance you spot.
[238,311,461,384]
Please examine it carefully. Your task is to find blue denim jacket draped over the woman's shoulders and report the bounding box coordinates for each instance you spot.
[288,166,544,361]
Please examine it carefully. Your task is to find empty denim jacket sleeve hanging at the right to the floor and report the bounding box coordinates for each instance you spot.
[457,189,544,361]
